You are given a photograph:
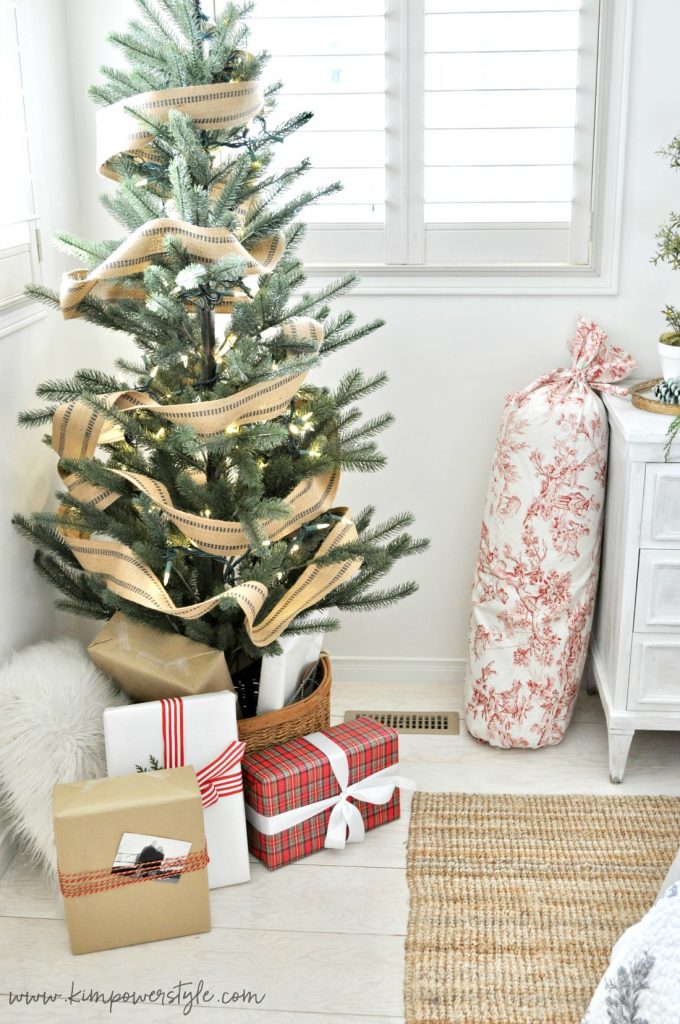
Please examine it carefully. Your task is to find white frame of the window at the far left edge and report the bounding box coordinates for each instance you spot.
[0,0,47,338]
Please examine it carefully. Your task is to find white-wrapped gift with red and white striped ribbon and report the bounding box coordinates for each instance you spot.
[103,692,250,889]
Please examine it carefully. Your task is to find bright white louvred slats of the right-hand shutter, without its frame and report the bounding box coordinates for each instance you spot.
[425,0,581,224]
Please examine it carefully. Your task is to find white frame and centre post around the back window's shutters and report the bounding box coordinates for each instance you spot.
[294,0,634,295]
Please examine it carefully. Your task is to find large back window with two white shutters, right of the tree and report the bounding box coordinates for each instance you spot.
[242,0,626,280]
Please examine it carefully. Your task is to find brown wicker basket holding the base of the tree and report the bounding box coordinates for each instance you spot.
[239,653,333,754]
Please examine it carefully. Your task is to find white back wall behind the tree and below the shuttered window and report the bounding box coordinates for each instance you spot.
[10,0,680,659]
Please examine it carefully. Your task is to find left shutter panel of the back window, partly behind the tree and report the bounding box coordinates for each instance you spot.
[242,0,386,262]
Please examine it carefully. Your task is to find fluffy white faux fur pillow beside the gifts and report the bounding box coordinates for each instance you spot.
[0,640,130,876]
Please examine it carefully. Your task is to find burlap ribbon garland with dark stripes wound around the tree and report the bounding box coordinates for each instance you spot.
[52,82,363,647]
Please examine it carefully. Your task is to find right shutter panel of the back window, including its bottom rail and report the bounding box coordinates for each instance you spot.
[423,0,599,264]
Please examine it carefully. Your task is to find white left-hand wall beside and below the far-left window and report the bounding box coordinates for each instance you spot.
[0,0,85,654]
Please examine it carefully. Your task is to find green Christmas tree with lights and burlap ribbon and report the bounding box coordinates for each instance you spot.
[14,0,427,688]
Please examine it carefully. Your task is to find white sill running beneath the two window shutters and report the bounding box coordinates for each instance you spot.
[305,263,618,296]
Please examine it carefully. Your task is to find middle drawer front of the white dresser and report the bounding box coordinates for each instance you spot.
[635,548,680,634]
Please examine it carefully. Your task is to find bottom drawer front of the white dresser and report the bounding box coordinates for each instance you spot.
[627,633,680,711]
